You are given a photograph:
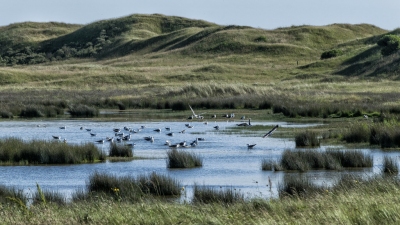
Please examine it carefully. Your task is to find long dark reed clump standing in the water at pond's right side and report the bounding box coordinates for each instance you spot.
[262,149,373,171]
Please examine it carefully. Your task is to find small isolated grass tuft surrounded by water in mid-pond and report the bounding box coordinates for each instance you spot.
[167,149,203,168]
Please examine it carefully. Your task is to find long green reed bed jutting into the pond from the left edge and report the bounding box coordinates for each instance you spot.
[0,137,106,165]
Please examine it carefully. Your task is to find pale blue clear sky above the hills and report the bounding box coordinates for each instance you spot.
[0,0,400,30]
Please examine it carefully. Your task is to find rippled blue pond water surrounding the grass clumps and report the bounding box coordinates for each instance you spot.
[0,120,399,199]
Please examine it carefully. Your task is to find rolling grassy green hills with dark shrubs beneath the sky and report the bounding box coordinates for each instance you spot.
[0,14,398,79]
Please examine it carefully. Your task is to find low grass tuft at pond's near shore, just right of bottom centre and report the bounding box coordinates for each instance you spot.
[193,184,245,204]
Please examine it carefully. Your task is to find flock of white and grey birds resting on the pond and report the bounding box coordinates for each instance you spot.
[53,105,278,149]
